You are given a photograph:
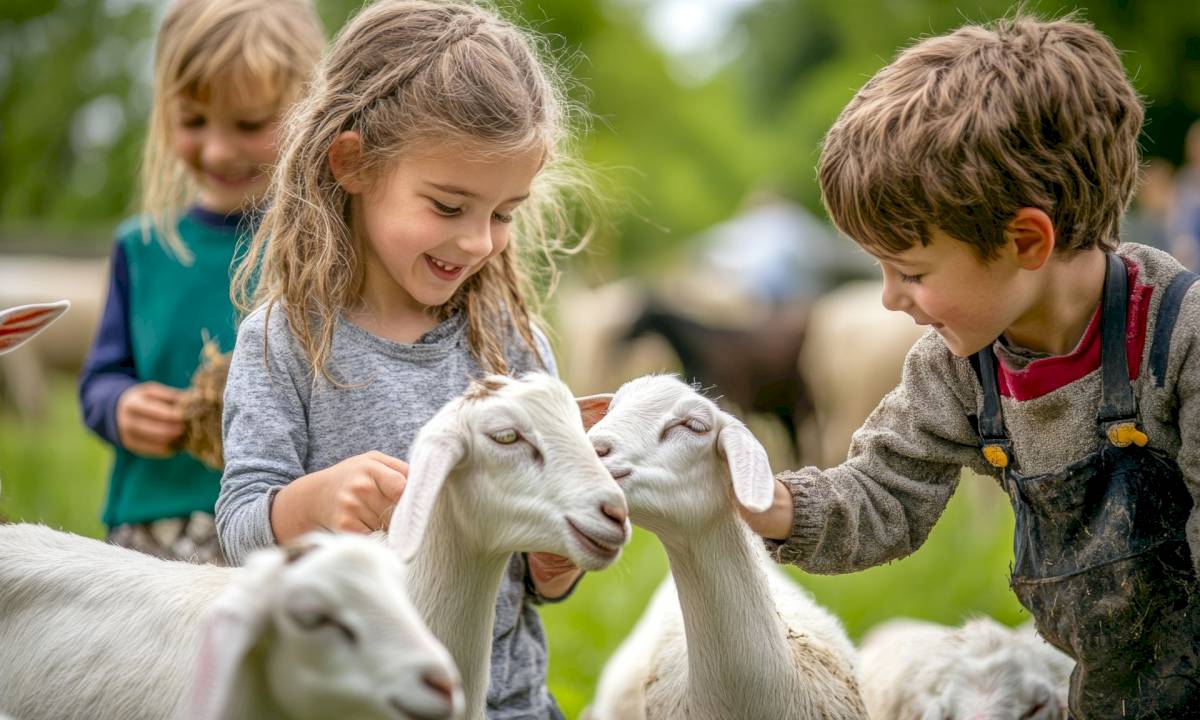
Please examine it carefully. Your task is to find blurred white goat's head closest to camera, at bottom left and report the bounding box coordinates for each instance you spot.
[187,533,464,720]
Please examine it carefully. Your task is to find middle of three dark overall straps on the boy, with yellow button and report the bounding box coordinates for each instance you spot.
[1098,253,1148,448]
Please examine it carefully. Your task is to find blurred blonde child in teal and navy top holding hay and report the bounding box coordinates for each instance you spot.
[79,0,324,562]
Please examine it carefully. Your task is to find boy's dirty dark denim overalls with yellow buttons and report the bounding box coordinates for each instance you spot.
[971,254,1200,720]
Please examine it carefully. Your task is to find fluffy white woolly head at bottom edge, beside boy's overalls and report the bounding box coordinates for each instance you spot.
[922,618,1070,720]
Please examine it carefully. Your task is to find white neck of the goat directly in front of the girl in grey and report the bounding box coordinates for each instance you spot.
[408,489,510,720]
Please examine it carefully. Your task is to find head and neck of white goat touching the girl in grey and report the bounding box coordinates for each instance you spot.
[389,374,629,719]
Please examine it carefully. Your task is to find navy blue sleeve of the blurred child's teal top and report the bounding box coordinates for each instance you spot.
[79,241,139,445]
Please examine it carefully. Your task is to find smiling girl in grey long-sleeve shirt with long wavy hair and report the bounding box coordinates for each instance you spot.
[217,0,595,719]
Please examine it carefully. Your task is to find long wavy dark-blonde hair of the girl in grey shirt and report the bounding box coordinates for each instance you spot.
[234,0,590,386]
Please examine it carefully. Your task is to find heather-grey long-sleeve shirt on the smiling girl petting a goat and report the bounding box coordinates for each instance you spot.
[216,306,562,720]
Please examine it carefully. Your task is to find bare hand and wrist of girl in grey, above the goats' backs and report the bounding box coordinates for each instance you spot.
[271,450,408,542]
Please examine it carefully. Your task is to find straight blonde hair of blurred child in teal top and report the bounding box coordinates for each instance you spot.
[142,0,325,264]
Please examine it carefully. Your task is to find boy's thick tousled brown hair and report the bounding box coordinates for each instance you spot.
[818,16,1144,260]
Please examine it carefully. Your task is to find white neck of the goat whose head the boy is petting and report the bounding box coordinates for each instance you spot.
[660,511,796,719]
